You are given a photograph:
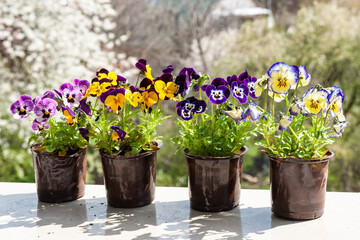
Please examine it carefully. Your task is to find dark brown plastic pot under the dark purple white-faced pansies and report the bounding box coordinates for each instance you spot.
[185,147,248,212]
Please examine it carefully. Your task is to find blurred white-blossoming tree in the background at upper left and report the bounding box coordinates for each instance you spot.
[0,0,134,140]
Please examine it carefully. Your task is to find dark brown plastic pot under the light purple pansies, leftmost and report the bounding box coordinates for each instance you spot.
[30,144,87,203]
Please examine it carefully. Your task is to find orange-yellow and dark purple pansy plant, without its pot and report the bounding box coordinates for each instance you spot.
[81,59,178,155]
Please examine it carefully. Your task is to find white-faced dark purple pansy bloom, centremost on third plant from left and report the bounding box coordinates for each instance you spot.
[201,78,230,104]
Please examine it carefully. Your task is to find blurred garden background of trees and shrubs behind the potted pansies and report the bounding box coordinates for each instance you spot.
[0,0,360,191]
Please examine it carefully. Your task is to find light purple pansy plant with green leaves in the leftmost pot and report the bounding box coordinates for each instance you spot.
[10,79,92,156]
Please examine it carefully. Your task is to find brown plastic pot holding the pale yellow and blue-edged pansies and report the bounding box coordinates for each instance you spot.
[268,151,334,220]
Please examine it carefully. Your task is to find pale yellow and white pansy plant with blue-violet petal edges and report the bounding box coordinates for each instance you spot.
[255,62,347,159]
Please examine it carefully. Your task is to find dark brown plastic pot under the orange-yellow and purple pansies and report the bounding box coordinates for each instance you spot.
[100,151,156,208]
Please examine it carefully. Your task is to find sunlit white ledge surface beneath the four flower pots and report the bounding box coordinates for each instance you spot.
[0,183,360,240]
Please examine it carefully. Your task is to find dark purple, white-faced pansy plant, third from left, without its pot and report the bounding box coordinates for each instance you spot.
[172,68,261,156]
